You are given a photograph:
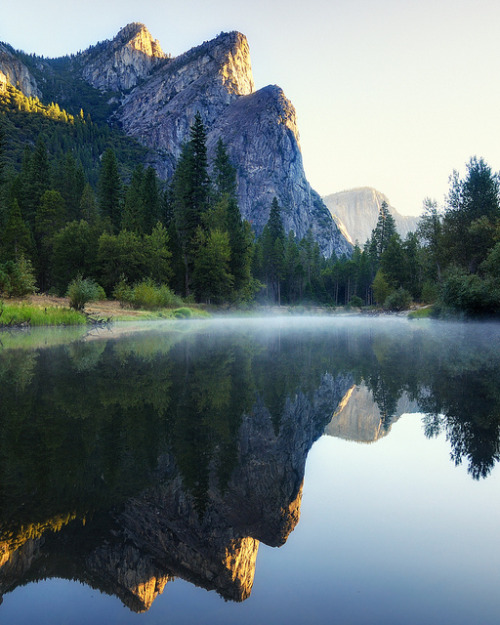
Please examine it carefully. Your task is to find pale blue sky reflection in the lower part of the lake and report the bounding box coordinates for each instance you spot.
[0,415,500,625]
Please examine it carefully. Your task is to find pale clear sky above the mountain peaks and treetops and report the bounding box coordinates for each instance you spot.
[0,0,500,214]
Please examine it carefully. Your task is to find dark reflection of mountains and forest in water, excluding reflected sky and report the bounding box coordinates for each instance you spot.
[0,319,500,611]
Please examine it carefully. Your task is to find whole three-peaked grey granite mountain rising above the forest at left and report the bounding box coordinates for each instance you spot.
[0,23,351,256]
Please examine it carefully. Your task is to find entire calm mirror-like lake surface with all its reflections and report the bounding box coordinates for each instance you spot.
[0,317,500,625]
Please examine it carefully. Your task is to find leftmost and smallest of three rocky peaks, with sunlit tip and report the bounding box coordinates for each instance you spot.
[81,23,167,91]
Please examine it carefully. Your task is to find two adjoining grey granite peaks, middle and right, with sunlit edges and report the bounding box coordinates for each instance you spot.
[117,32,351,256]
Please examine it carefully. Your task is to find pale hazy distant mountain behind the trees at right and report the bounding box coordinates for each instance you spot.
[323,187,419,245]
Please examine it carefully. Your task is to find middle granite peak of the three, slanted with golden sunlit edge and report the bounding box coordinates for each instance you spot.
[117,32,254,166]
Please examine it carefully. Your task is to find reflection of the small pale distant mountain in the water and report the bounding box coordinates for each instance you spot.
[325,384,418,443]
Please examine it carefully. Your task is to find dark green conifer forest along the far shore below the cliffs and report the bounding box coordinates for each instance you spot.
[0,81,500,315]
